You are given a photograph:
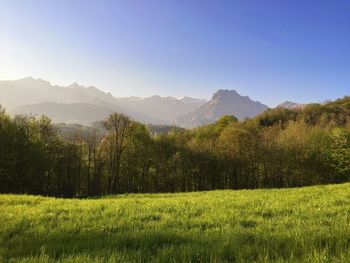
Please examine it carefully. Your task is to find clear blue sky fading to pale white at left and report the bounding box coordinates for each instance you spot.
[0,0,350,106]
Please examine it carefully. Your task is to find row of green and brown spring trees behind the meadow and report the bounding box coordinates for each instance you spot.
[0,97,350,197]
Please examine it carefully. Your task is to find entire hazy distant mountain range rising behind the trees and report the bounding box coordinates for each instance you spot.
[0,77,290,127]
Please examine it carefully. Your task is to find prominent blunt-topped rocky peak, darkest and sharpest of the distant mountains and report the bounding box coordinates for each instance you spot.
[176,90,268,127]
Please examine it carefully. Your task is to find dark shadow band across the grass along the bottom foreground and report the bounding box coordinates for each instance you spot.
[1,228,350,262]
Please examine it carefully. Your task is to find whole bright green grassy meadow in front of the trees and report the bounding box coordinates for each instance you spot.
[0,184,350,262]
